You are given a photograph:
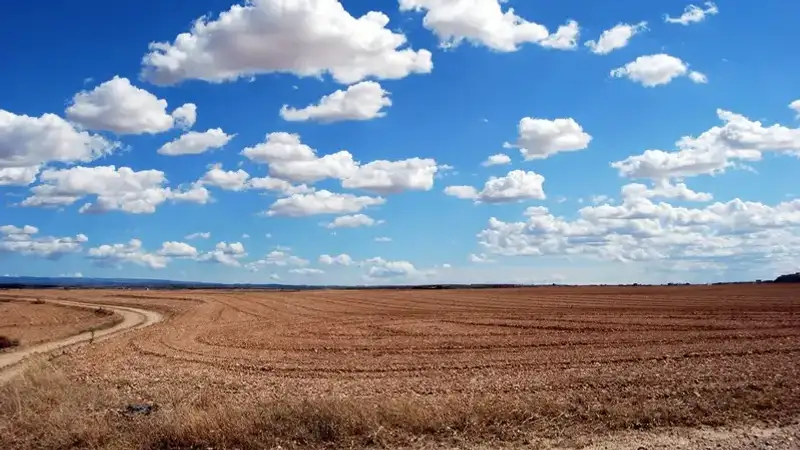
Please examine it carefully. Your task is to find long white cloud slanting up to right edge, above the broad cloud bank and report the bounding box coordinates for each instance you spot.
[611,105,800,180]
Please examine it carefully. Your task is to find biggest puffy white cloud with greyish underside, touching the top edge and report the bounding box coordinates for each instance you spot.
[142,0,433,85]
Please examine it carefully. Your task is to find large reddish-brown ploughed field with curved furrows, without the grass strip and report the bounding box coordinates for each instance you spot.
[1,285,800,448]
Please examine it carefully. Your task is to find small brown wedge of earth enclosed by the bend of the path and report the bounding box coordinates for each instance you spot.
[0,294,120,348]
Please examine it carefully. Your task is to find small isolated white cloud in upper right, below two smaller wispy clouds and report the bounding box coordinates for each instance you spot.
[611,53,708,87]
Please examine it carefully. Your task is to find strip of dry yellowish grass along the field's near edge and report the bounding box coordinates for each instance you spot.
[0,362,796,450]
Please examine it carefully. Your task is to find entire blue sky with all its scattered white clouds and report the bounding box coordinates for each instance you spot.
[0,0,800,284]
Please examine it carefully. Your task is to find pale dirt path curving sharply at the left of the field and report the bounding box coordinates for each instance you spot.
[0,300,164,384]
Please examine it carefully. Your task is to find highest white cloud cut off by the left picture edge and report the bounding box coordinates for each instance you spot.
[0,109,119,185]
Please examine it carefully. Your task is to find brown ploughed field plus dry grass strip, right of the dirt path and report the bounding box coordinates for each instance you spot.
[0,285,800,449]
